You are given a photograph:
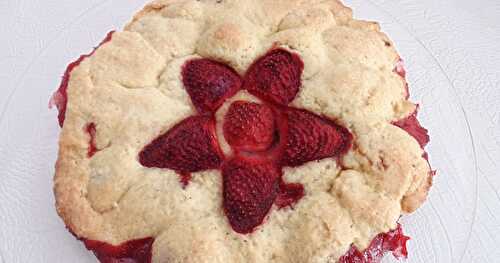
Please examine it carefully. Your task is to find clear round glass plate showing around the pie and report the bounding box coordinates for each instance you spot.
[0,0,477,263]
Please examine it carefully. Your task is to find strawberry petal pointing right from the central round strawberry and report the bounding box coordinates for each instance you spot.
[281,108,352,166]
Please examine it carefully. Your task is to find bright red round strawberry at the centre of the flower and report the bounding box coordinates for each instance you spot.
[223,101,275,154]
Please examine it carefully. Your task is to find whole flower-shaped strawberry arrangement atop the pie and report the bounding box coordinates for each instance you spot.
[139,48,352,234]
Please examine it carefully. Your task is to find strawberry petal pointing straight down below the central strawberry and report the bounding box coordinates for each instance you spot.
[222,158,281,234]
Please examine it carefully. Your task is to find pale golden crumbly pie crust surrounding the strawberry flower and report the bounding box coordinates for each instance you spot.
[55,0,431,263]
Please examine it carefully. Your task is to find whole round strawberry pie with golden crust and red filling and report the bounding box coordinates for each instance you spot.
[52,0,433,263]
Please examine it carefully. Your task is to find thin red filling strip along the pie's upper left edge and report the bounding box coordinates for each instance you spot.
[50,31,115,127]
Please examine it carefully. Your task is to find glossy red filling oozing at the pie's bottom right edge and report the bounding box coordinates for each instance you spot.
[339,224,410,263]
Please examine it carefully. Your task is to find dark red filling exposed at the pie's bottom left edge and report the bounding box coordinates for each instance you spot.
[82,237,154,263]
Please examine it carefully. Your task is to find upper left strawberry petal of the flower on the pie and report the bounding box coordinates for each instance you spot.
[182,59,242,113]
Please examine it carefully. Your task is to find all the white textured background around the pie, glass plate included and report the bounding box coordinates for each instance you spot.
[0,0,500,263]
